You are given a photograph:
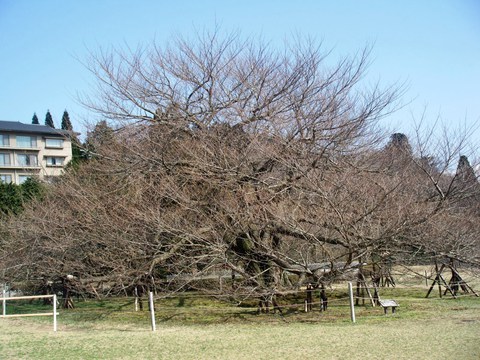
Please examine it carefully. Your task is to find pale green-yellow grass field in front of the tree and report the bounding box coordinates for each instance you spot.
[0,272,480,359]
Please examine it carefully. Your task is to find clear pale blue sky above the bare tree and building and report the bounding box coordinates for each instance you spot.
[0,0,480,145]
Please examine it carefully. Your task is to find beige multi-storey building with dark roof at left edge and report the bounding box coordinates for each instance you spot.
[0,121,72,184]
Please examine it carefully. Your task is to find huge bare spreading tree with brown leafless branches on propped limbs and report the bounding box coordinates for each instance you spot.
[1,32,480,300]
